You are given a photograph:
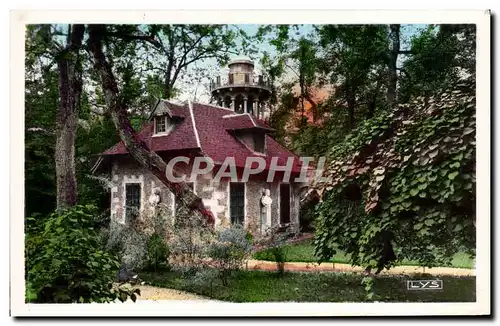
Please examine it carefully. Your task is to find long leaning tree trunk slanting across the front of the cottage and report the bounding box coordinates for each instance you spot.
[88,25,215,225]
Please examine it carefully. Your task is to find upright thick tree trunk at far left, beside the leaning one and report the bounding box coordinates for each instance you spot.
[55,24,85,214]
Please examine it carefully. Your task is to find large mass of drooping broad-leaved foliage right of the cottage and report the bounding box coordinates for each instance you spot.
[314,80,475,269]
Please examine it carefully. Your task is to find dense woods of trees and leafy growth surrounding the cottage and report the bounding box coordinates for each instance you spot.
[25,24,476,302]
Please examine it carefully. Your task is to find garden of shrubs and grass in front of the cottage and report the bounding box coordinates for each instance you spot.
[26,206,475,303]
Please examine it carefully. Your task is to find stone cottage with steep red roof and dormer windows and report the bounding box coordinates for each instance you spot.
[94,58,303,234]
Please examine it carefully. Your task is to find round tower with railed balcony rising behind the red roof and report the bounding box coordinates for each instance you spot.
[210,57,272,119]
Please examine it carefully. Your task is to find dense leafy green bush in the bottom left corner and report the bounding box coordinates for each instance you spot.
[26,206,137,303]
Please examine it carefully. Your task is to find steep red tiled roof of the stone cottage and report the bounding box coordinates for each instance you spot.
[103,102,300,172]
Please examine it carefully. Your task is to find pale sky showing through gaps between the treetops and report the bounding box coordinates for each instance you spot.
[177,24,427,102]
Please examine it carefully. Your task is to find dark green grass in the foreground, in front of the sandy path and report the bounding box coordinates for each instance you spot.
[140,271,476,302]
